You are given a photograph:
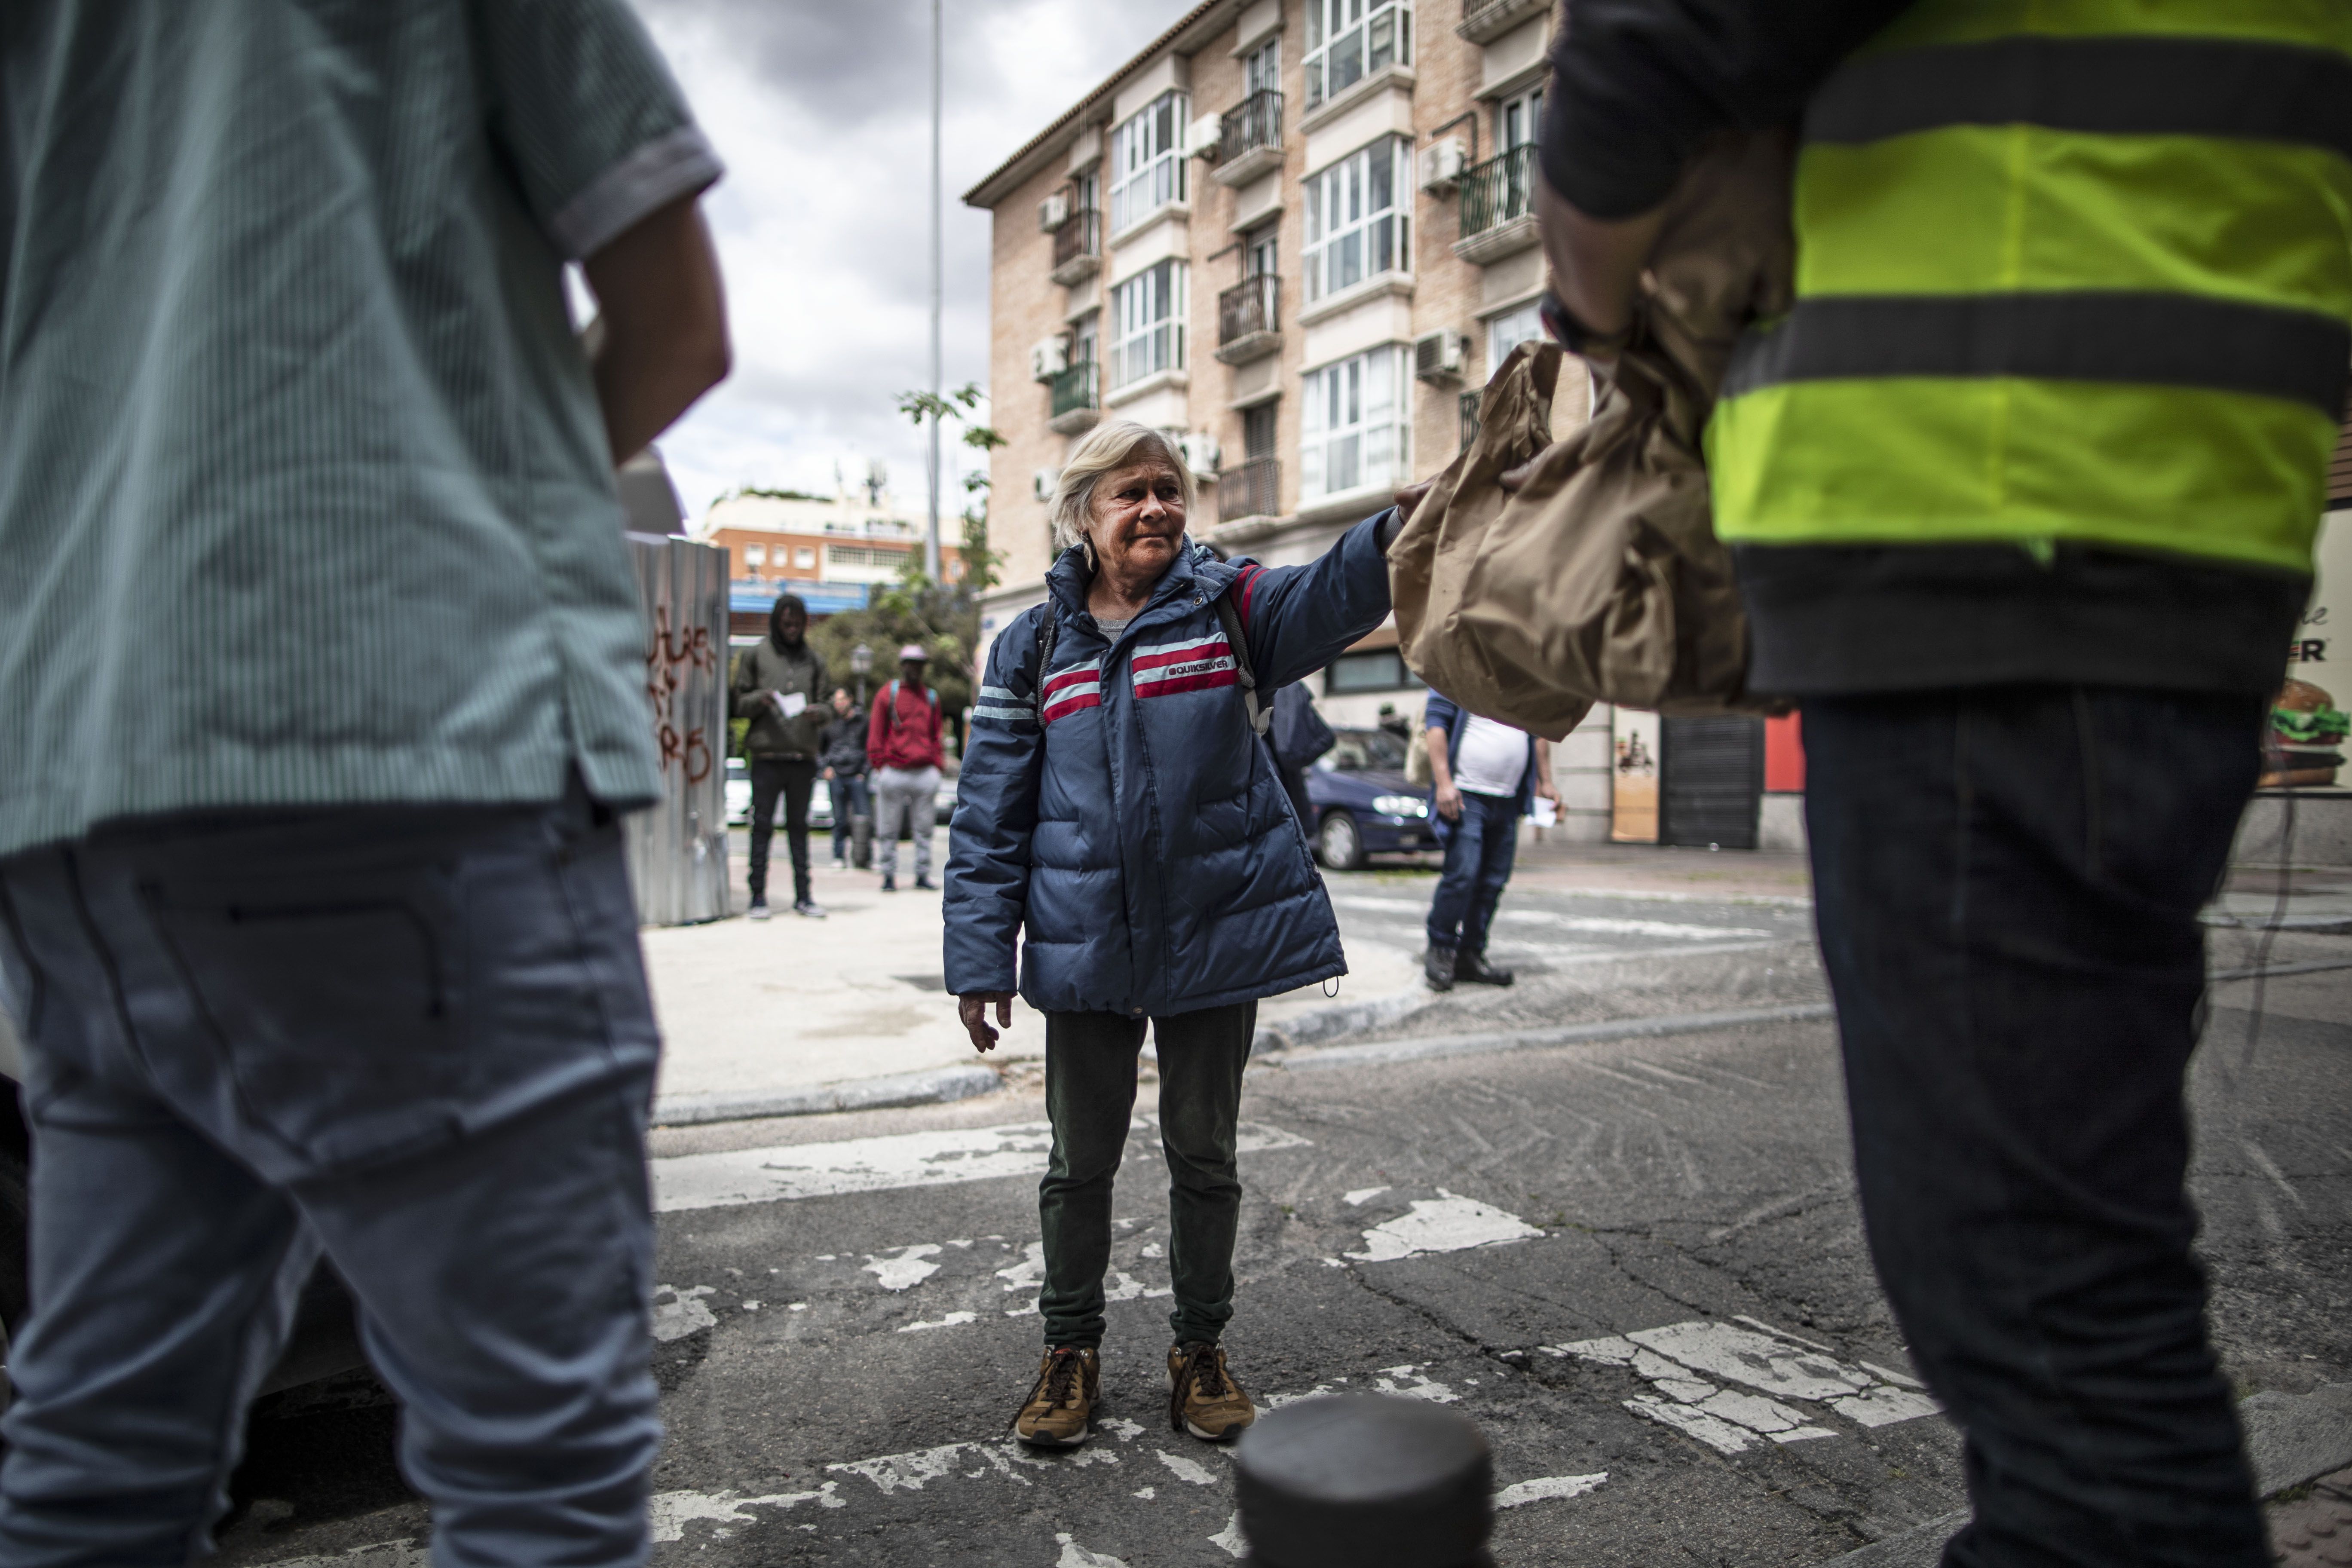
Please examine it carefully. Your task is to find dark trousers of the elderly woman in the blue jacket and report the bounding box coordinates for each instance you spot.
[1037,1001,1259,1344]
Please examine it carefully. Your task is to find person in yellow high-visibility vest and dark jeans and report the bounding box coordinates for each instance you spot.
[1538,0,2352,1568]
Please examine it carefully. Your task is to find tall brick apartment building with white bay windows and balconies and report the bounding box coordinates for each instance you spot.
[965,0,1614,837]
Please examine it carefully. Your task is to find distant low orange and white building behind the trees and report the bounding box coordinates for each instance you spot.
[687,482,965,640]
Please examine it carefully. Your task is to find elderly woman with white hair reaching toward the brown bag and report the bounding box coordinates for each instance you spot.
[946,421,1400,1446]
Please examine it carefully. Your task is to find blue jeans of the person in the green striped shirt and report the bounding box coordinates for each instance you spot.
[0,787,661,1568]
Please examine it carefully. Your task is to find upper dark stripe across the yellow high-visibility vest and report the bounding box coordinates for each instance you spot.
[1804,38,2352,157]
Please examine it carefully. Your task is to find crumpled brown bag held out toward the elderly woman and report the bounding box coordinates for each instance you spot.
[1387,134,1795,741]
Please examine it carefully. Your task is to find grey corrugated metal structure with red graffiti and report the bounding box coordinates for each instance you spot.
[628,534,732,926]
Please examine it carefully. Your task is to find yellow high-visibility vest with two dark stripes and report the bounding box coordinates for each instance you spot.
[1708,0,2352,571]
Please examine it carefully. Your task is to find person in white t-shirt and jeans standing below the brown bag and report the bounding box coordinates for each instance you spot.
[1421,691,1559,990]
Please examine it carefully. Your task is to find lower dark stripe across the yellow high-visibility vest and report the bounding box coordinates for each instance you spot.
[1724,291,2352,419]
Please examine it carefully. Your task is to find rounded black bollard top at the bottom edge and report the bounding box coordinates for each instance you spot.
[1232,1394,1494,1568]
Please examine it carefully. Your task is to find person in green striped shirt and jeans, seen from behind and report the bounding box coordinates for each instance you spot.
[0,0,729,1568]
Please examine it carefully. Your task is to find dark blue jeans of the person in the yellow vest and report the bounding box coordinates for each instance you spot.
[1804,686,2269,1568]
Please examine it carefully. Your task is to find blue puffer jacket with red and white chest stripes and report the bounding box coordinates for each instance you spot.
[946,517,1387,1016]
